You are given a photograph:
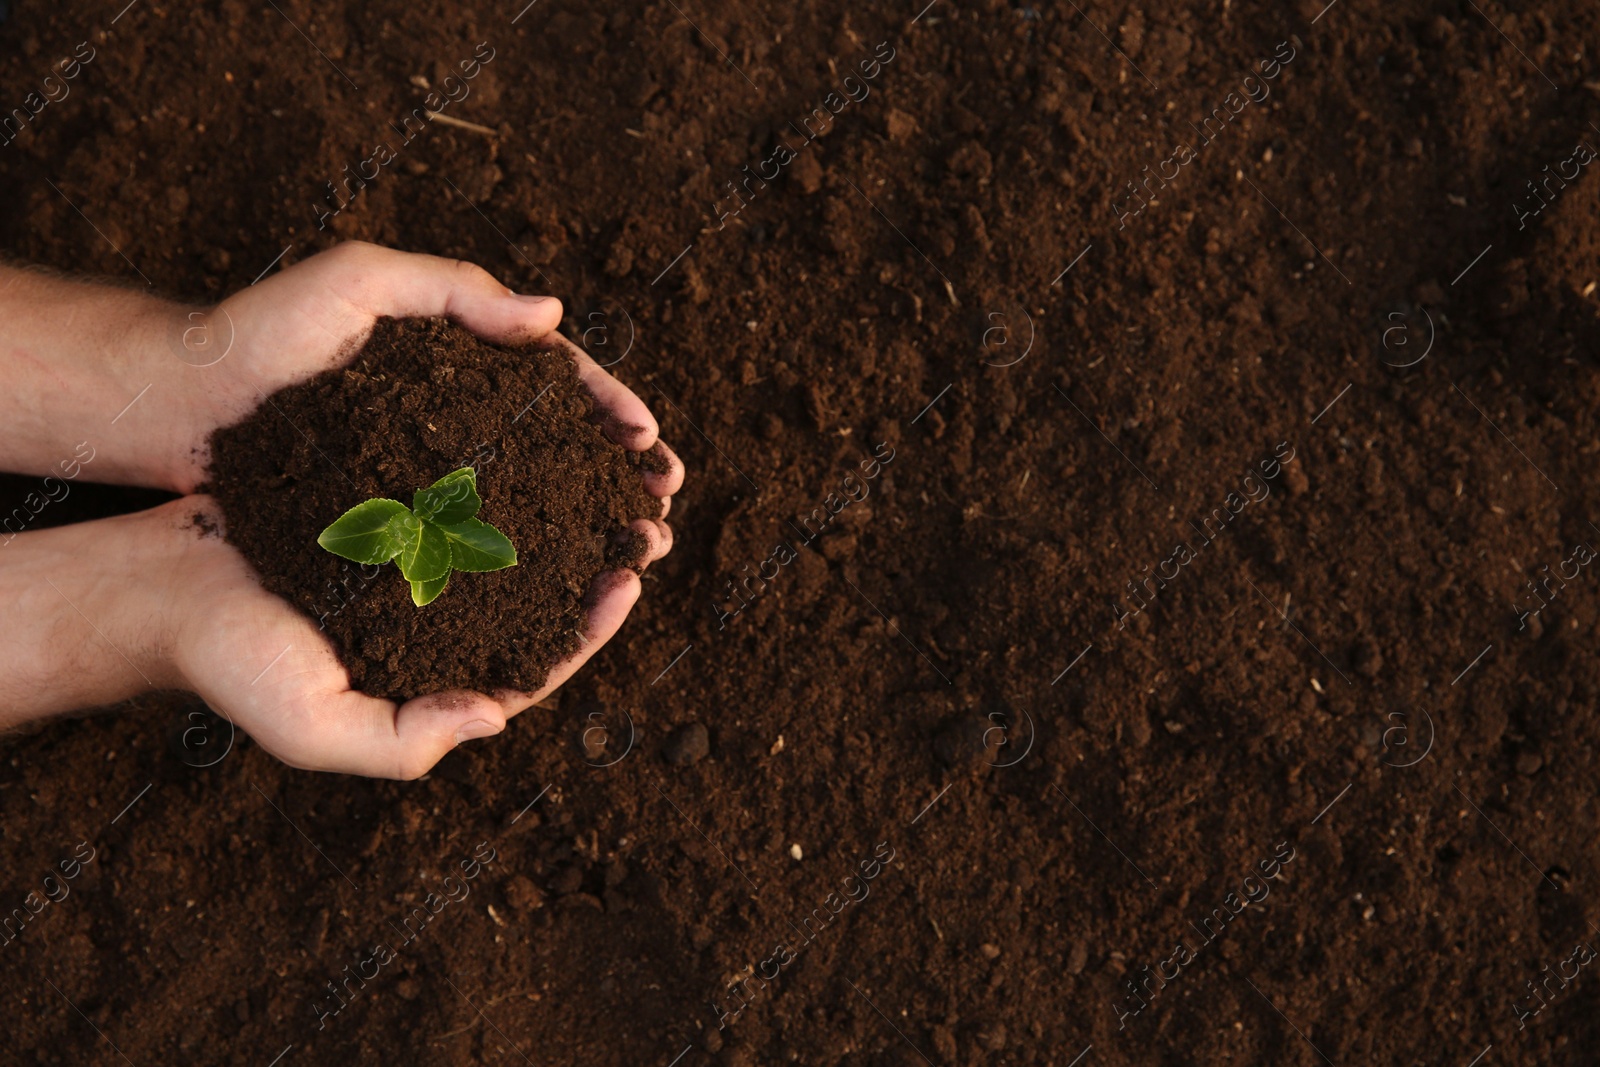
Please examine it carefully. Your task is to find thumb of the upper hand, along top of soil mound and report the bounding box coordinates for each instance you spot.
[306,242,562,344]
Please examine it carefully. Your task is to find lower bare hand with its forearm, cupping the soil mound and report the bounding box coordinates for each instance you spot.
[0,496,667,779]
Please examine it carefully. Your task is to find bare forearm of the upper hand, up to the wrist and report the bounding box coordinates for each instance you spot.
[0,266,195,488]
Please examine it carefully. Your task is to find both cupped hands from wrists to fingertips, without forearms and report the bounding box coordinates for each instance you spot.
[149,243,683,777]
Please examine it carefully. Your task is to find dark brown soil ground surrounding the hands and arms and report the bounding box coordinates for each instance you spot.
[0,0,1600,1067]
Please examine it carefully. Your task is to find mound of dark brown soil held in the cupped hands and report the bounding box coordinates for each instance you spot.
[208,318,661,701]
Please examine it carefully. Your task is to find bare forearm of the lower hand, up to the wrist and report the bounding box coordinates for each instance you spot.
[0,515,174,729]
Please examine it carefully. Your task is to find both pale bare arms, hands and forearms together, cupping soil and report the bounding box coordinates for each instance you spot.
[0,242,683,779]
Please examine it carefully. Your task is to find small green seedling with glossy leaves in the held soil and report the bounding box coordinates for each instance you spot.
[317,467,517,608]
